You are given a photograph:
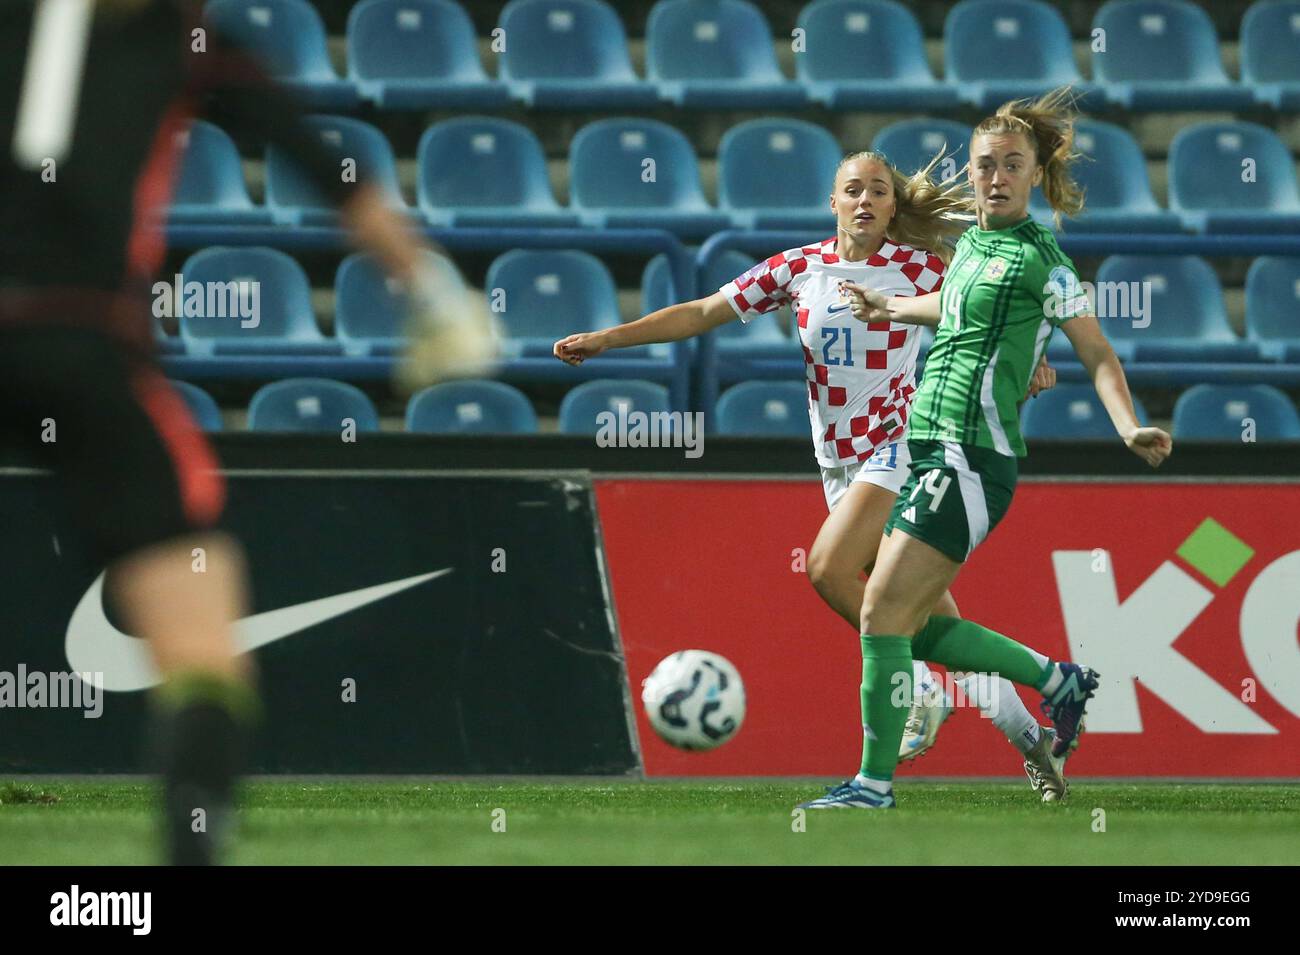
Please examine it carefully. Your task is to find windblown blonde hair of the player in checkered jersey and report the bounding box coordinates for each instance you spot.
[835,151,975,265]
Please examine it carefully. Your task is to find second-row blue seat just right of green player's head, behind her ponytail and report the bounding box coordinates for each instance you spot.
[1030,120,1183,233]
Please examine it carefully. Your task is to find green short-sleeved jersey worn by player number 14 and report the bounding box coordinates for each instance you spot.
[907,220,1092,457]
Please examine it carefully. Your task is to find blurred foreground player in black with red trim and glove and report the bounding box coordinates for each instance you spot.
[0,0,490,864]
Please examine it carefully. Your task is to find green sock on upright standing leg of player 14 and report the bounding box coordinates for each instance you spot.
[862,633,911,781]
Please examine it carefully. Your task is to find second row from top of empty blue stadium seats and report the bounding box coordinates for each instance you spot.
[168,116,1300,238]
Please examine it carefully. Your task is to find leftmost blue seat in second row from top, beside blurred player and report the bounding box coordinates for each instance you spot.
[166,120,270,225]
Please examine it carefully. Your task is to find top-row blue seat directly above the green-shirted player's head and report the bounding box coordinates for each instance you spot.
[944,0,1093,110]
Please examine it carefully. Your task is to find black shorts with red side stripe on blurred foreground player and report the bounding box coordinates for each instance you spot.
[0,325,225,565]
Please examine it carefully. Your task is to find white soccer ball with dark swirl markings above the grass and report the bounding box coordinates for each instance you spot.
[641,650,745,750]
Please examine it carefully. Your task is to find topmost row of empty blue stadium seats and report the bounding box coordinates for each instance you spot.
[205,0,1300,110]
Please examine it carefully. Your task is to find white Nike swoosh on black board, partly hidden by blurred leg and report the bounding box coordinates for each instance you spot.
[64,567,454,693]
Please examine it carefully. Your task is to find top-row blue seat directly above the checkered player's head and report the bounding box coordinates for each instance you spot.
[794,0,958,112]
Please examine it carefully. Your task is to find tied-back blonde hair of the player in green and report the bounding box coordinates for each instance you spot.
[972,86,1083,229]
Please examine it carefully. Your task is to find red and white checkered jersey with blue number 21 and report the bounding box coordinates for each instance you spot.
[719,238,944,468]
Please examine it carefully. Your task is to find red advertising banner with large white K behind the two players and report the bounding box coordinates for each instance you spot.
[597,479,1300,778]
